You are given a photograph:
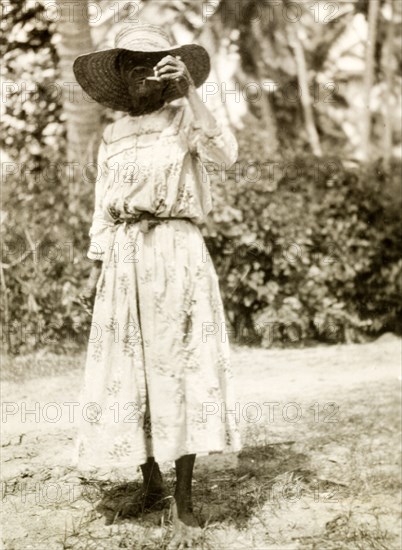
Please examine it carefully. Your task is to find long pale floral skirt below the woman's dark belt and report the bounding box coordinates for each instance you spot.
[73,220,240,478]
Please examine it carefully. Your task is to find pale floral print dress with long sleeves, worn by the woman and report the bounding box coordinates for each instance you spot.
[73,103,240,478]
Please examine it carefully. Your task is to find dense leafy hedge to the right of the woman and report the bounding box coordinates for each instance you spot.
[207,126,402,346]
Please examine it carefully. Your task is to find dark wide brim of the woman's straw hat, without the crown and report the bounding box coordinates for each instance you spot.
[73,44,211,112]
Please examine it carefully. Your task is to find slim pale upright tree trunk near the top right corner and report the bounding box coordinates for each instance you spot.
[362,0,380,162]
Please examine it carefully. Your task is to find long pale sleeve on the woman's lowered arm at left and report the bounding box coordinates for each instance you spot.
[87,125,114,260]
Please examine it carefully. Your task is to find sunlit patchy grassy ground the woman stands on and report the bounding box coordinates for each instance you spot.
[2,337,402,550]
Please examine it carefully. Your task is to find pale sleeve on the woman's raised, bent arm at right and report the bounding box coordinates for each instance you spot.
[184,104,238,169]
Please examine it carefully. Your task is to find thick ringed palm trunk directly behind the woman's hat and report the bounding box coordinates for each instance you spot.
[57,0,102,198]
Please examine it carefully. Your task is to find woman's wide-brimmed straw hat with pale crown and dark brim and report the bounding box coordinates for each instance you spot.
[73,24,211,112]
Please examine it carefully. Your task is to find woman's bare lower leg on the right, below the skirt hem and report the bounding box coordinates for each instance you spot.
[174,454,198,526]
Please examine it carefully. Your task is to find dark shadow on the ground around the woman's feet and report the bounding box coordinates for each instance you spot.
[91,441,324,527]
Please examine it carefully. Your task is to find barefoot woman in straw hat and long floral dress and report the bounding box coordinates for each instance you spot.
[74,25,240,540]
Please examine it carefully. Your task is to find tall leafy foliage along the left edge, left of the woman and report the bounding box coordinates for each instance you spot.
[0,0,93,352]
